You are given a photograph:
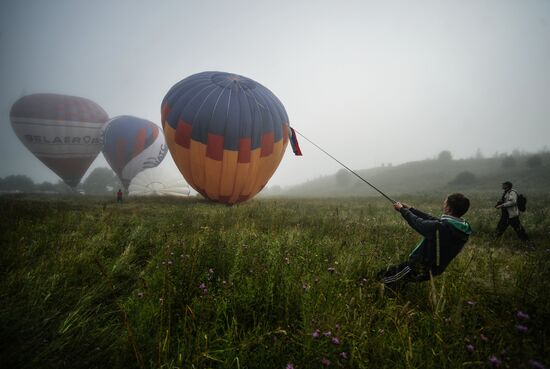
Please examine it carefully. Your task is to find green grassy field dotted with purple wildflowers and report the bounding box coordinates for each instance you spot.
[0,194,550,368]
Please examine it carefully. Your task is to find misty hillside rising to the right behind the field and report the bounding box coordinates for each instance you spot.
[276,153,550,197]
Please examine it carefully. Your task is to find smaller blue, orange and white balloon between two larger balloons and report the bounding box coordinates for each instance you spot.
[103,115,168,190]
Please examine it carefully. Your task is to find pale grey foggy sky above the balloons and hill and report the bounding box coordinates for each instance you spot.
[0,0,550,186]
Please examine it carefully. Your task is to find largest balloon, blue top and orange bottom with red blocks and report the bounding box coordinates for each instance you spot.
[161,72,288,204]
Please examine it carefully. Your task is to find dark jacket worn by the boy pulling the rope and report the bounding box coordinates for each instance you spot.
[400,208,472,276]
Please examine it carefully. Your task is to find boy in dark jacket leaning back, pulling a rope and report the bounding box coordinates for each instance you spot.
[377,193,472,285]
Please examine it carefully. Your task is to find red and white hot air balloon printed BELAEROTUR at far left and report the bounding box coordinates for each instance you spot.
[10,94,109,188]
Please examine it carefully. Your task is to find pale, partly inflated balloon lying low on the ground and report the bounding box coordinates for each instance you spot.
[128,165,191,197]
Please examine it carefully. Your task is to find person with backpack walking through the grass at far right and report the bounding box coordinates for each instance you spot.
[495,181,529,241]
